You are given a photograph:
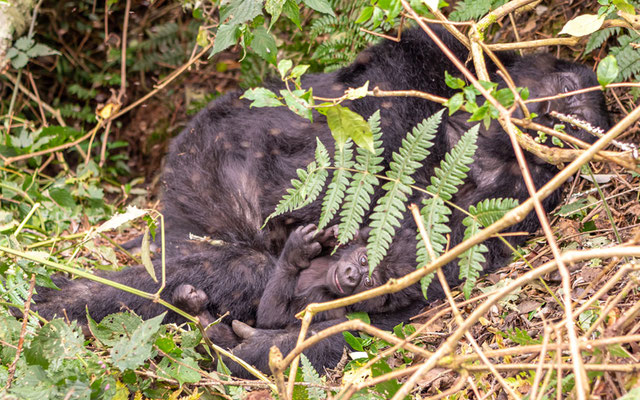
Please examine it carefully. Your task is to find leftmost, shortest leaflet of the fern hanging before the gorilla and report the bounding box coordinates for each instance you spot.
[265,138,330,224]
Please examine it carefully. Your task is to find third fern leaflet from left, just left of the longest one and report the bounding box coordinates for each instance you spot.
[338,111,383,244]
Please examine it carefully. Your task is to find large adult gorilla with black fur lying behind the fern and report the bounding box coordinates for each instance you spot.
[31,29,608,374]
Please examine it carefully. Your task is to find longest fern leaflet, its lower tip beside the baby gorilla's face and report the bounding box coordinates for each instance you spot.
[367,110,444,271]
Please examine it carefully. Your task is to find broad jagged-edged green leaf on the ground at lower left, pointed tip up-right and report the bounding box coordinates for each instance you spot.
[111,312,167,371]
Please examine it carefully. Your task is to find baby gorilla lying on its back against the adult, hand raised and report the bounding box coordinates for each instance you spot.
[172,225,379,340]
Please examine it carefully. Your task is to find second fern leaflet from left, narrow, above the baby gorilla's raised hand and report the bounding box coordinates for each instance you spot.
[318,139,355,229]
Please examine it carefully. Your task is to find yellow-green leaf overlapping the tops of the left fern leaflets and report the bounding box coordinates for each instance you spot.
[327,104,374,153]
